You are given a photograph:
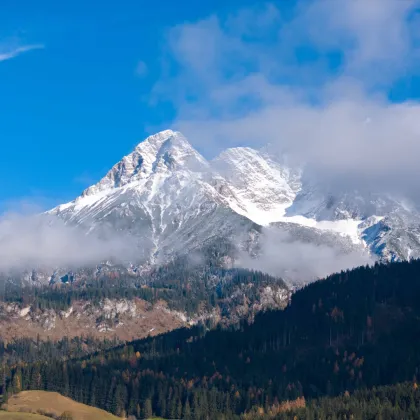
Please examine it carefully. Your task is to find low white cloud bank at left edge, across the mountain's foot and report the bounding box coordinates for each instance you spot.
[0,214,138,271]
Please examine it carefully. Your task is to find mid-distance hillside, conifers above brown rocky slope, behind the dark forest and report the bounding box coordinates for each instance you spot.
[0,268,290,346]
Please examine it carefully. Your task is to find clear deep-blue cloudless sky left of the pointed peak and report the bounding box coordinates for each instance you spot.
[0,0,256,207]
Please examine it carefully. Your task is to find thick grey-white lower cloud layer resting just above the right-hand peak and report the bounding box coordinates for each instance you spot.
[178,98,420,199]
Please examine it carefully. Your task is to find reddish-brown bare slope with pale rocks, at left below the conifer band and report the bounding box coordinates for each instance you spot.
[0,299,187,340]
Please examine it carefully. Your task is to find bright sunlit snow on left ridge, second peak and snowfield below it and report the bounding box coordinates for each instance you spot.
[50,130,370,244]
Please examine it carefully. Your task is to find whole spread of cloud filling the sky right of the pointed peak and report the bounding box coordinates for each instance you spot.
[148,0,420,202]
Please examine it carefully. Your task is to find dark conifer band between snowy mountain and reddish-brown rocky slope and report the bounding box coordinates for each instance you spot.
[0,258,288,315]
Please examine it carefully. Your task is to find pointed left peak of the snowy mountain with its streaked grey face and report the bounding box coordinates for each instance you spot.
[50,130,258,263]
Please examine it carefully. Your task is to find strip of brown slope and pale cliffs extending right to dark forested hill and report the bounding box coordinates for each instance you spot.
[0,284,290,341]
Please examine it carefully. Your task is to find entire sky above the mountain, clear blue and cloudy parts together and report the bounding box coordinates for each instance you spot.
[0,0,420,212]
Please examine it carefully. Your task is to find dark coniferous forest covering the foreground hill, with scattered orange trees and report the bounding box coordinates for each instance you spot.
[0,261,420,419]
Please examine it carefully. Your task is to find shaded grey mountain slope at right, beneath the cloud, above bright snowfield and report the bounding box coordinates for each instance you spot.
[286,180,420,261]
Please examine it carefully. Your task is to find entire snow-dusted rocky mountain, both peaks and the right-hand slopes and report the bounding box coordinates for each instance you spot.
[41,130,420,280]
